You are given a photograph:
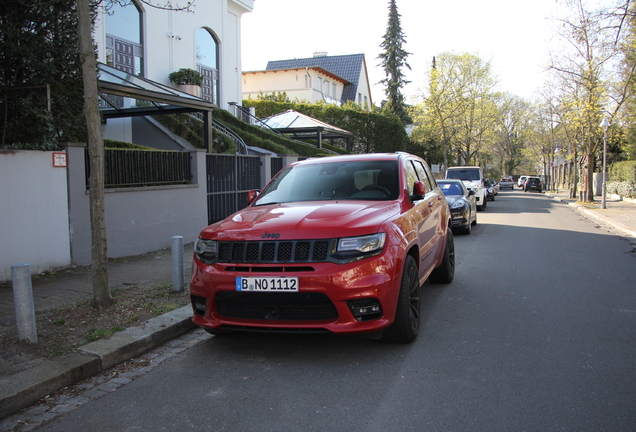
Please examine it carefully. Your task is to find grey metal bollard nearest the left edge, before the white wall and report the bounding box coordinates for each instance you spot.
[11,263,38,344]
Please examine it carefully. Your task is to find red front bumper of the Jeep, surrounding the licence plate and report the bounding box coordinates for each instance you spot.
[190,250,403,333]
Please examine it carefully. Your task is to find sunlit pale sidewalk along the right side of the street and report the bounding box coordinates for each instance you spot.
[546,191,636,238]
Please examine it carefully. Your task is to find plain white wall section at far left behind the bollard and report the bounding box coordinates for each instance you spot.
[0,150,71,281]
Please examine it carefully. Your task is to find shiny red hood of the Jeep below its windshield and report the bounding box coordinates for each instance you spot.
[201,201,399,241]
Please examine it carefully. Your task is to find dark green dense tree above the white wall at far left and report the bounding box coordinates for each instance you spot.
[0,0,86,149]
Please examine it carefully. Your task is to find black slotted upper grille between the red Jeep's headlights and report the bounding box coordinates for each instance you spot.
[219,239,332,263]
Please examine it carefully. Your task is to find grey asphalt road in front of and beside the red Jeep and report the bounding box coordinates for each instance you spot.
[39,189,636,432]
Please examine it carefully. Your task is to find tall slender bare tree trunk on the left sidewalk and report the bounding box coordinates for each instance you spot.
[76,0,114,309]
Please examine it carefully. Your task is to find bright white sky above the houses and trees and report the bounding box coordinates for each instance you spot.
[241,0,555,105]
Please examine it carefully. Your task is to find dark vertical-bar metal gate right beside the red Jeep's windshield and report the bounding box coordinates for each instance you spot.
[206,154,261,224]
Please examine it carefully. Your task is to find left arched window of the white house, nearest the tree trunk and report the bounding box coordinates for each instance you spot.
[106,0,144,76]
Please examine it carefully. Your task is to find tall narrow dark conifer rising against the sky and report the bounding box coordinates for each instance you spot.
[378,0,411,124]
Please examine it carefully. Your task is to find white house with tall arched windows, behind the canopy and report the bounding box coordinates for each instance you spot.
[93,0,254,142]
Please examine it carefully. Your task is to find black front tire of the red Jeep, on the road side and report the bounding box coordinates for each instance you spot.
[383,255,420,343]
